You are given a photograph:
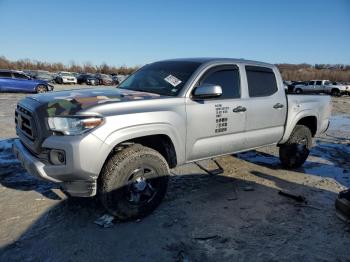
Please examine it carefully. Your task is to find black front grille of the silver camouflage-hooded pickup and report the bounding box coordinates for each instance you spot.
[15,105,35,141]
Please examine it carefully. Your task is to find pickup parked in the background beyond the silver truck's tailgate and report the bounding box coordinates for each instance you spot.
[295,80,350,96]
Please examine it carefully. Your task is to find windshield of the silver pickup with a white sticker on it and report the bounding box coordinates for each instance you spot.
[119,61,201,96]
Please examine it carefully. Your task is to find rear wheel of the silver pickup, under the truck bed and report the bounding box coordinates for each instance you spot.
[279,125,312,168]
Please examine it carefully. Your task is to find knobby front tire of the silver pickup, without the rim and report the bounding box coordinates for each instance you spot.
[98,144,169,221]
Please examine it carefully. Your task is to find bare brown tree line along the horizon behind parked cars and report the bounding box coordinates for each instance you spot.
[0,56,350,82]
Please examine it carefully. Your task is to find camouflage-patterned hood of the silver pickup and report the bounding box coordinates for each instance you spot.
[30,88,162,116]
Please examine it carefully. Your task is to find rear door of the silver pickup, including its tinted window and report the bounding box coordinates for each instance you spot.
[245,66,287,148]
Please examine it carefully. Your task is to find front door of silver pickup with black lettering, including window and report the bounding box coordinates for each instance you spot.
[186,65,246,161]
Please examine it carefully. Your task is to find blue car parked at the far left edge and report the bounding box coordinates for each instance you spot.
[0,70,54,93]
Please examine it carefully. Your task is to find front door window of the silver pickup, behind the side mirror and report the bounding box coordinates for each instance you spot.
[201,69,240,99]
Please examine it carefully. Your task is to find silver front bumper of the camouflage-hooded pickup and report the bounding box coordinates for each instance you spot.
[12,137,103,197]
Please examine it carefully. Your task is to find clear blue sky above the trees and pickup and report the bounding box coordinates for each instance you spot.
[0,0,350,66]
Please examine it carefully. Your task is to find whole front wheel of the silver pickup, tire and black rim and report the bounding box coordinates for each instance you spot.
[99,144,169,221]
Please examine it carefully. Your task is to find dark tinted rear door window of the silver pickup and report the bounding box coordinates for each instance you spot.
[245,66,277,97]
